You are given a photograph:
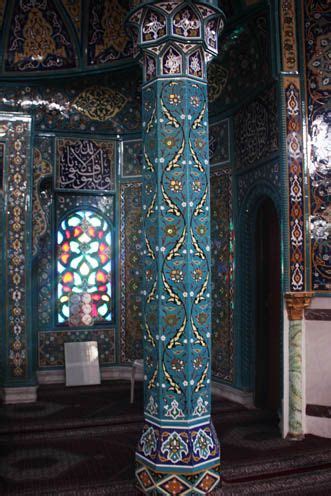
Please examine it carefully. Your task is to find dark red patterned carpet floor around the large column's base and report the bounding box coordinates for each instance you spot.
[0,381,331,496]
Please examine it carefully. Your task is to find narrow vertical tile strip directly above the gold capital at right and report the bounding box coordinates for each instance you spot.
[284,77,305,291]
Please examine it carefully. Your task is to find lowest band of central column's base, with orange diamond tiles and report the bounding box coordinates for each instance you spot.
[136,460,220,496]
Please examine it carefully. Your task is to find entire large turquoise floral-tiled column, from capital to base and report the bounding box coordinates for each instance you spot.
[129,1,223,495]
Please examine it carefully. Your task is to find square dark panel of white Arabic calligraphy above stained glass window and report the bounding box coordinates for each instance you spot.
[56,138,115,191]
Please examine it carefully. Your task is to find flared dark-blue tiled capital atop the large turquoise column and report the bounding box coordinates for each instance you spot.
[127,0,225,82]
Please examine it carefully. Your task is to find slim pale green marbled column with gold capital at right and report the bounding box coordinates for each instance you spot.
[285,293,312,440]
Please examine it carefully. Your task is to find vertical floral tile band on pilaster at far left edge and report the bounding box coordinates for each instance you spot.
[0,114,32,380]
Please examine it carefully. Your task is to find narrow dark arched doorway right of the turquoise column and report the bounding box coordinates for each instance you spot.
[255,198,281,412]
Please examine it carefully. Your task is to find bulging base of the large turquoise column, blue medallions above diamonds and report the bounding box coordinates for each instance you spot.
[136,418,220,496]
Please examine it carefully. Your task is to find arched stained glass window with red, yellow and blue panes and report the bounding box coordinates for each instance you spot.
[57,210,112,325]
